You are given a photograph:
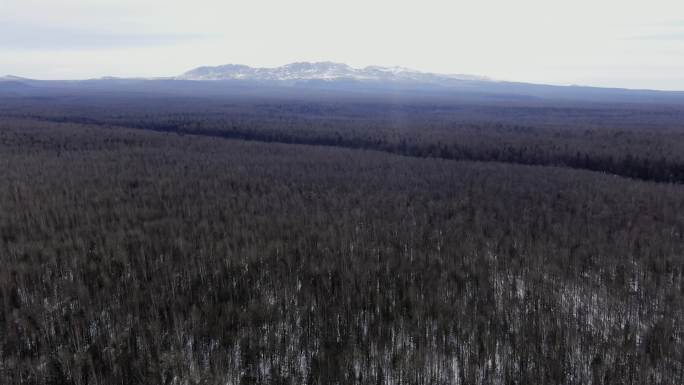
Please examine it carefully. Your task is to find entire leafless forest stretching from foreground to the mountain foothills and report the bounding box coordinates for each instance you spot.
[0,91,684,385]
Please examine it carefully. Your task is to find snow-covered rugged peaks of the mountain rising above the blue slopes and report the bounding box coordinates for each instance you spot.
[176,62,487,83]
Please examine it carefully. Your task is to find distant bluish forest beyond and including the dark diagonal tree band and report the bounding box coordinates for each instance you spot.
[0,96,684,183]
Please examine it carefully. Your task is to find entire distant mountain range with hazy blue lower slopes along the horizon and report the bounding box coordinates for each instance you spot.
[0,62,684,105]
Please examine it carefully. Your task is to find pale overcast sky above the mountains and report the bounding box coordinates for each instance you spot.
[0,0,684,90]
